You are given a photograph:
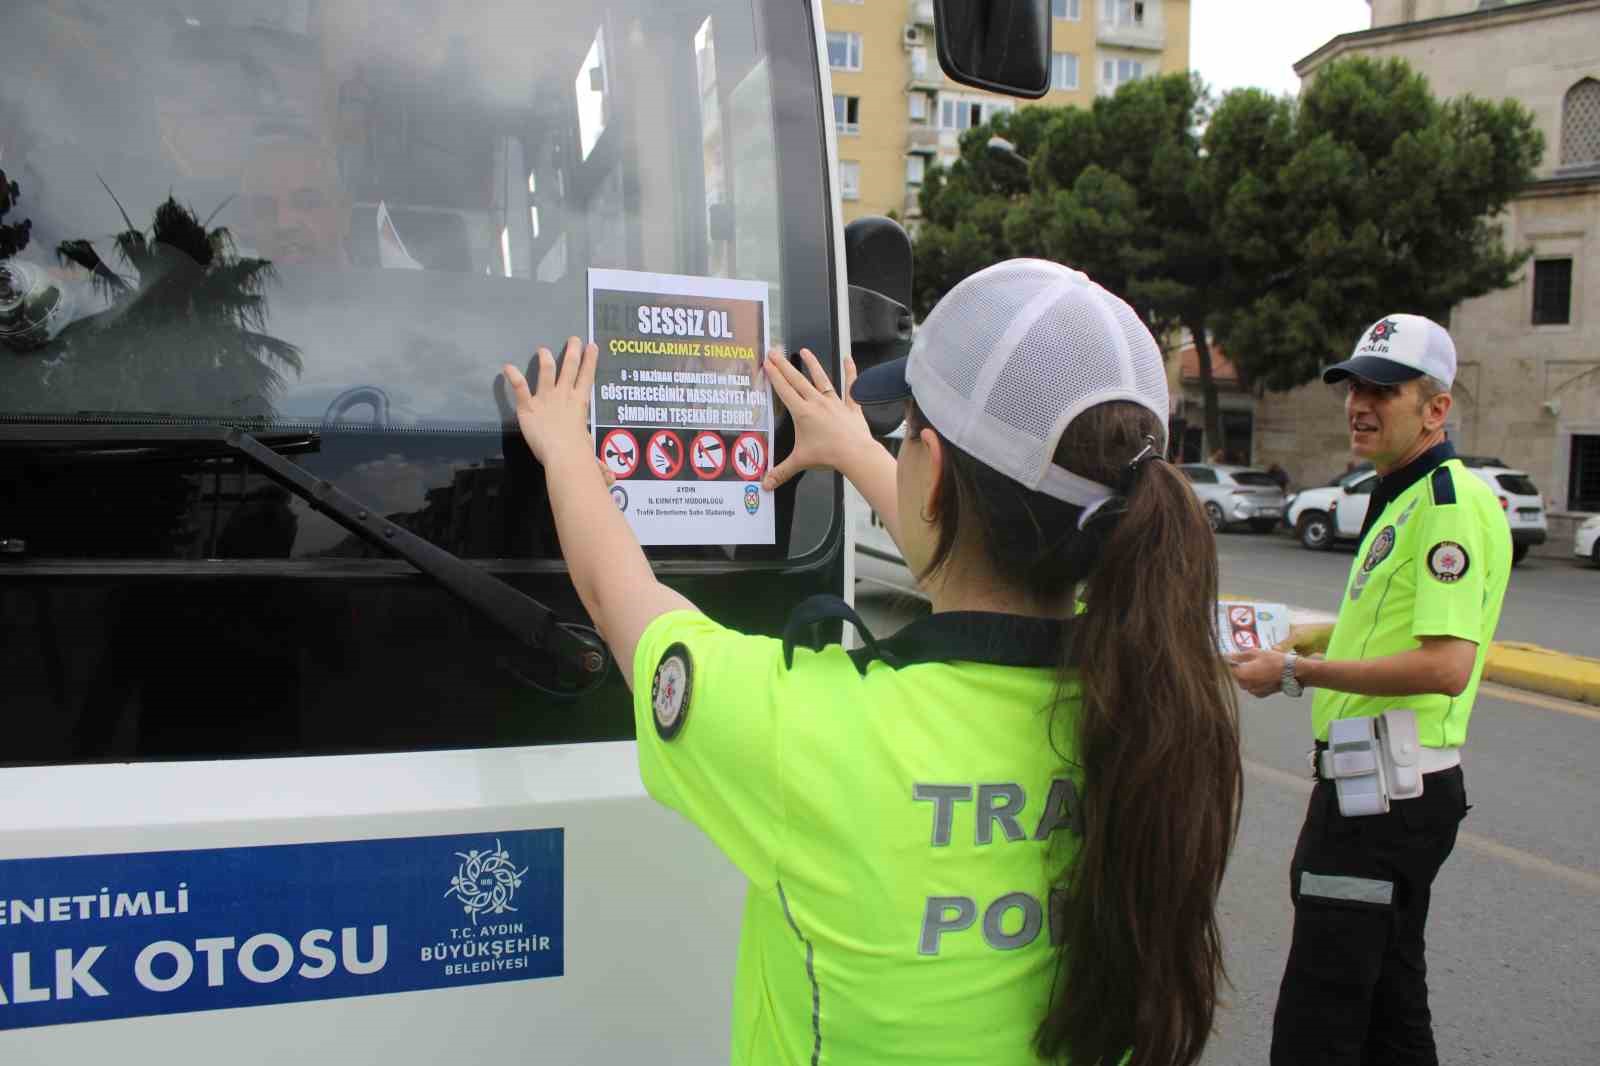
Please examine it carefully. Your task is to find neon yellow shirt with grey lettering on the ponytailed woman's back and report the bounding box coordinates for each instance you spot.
[634,611,1082,1066]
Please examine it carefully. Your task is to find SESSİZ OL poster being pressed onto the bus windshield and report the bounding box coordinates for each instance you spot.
[589,269,776,544]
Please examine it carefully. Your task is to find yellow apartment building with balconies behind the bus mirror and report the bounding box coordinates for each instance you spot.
[822,0,1190,226]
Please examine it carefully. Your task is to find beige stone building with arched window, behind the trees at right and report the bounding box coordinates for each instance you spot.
[1254,0,1600,554]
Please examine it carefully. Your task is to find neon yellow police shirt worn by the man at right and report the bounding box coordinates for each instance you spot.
[1312,443,1510,747]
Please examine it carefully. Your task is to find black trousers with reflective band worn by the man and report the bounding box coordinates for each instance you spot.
[1272,767,1467,1066]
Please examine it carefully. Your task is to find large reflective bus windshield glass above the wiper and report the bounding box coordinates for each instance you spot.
[0,0,782,432]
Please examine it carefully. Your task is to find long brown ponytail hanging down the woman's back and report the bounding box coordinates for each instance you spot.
[1037,411,1243,1066]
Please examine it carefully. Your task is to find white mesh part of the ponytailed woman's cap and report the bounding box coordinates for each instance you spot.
[906,259,1168,507]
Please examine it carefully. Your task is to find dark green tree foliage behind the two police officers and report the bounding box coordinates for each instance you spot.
[915,58,1544,412]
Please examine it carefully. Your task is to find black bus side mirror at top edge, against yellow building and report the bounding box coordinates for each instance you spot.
[933,0,1050,99]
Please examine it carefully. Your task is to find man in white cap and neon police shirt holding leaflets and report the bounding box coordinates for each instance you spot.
[1234,314,1510,1066]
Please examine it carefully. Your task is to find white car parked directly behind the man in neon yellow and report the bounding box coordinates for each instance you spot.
[1288,456,1549,565]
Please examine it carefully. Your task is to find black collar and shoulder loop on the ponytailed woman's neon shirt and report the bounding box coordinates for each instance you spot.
[784,595,1074,674]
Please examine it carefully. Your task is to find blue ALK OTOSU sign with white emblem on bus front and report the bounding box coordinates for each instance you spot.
[0,829,565,1029]
